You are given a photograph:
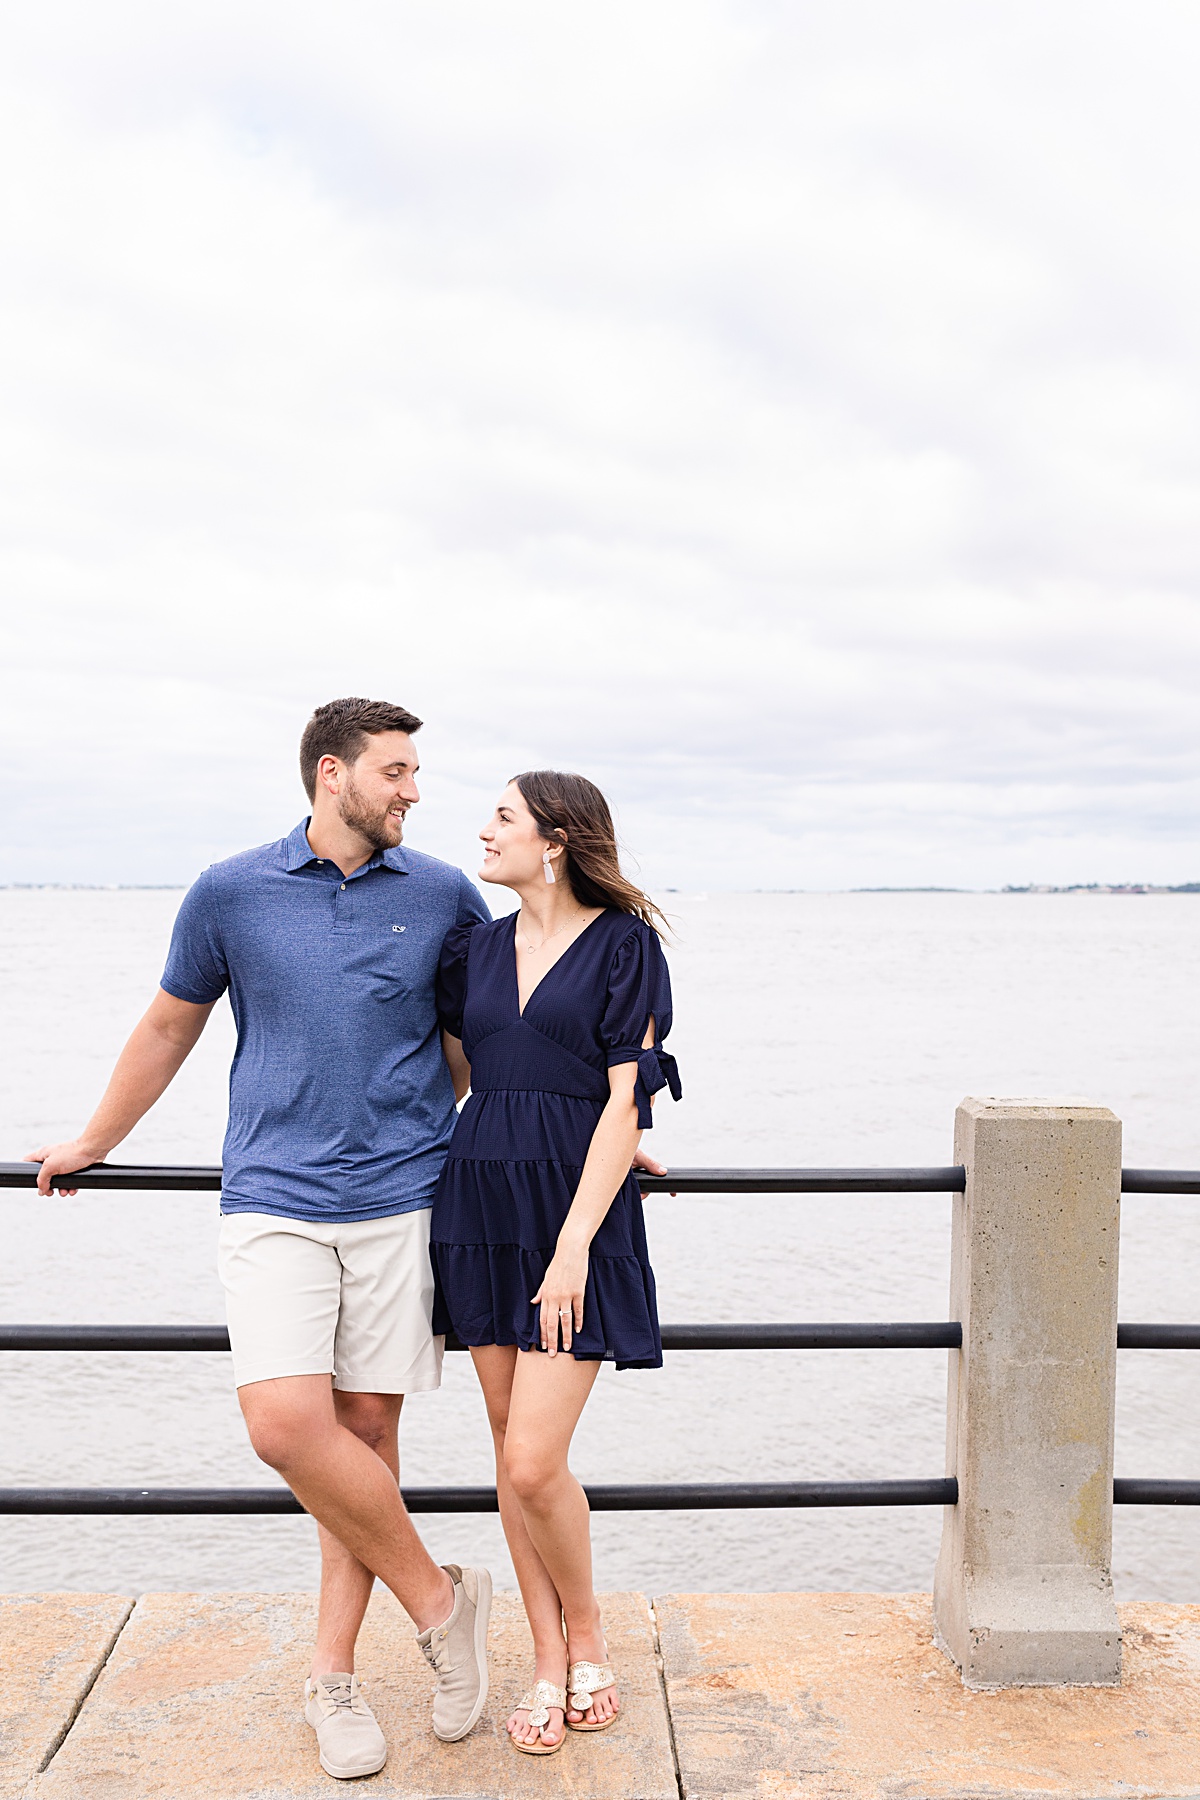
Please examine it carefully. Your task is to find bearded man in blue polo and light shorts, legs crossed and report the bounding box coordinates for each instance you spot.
[31,700,491,1778]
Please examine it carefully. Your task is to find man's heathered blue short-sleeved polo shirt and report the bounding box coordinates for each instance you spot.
[162,819,491,1222]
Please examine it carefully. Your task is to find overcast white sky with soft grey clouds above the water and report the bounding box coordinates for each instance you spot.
[0,0,1200,889]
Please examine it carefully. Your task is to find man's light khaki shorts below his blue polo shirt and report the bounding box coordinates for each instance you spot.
[218,1206,444,1393]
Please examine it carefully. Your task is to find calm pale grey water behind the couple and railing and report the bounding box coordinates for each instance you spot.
[0,891,1200,1600]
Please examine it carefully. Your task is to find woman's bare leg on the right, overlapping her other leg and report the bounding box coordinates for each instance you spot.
[504,1350,617,1724]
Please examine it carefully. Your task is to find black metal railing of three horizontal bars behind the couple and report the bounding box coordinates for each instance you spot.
[0,1163,1200,1514]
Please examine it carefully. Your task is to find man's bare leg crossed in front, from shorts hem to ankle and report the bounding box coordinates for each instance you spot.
[237,1375,453,1631]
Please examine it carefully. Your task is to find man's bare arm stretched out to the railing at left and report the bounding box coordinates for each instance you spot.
[25,988,216,1193]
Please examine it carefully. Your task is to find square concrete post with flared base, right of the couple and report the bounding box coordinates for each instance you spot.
[934,1100,1121,1688]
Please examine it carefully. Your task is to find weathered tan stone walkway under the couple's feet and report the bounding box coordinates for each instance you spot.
[0,1593,1200,1800]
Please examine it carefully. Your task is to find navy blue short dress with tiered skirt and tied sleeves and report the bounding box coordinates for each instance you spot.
[430,909,680,1368]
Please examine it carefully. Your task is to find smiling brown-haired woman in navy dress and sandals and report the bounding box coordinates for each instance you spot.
[430,770,680,1755]
